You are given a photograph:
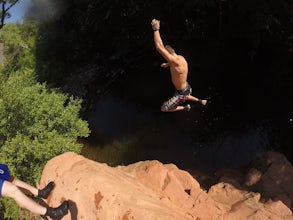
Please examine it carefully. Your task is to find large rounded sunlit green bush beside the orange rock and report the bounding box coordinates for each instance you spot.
[0,70,89,183]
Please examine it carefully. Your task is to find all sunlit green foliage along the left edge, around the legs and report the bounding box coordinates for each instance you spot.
[0,22,89,219]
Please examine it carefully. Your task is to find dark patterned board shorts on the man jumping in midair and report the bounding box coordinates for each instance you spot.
[162,83,192,111]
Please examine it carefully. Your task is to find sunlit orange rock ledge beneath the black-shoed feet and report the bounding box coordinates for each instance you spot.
[40,152,293,220]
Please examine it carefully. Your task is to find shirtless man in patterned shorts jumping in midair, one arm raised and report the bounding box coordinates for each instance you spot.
[151,19,207,112]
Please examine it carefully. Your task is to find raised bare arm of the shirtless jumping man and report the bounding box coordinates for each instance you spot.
[151,19,174,62]
